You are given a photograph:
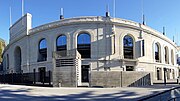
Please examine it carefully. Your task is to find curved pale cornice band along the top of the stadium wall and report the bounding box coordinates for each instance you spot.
[29,16,177,47]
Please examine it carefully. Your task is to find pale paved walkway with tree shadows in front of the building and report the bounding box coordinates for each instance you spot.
[0,84,180,101]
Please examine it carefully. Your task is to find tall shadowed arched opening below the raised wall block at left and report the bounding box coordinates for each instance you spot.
[14,47,22,73]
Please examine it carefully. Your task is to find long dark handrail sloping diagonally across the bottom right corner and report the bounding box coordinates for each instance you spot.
[138,86,180,101]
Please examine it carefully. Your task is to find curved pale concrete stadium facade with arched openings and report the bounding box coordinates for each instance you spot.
[3,14,178,86]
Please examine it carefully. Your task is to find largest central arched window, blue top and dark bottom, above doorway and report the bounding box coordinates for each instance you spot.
[77,33,91,58]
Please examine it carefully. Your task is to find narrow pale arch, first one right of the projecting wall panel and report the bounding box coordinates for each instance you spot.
[154,42,161,62]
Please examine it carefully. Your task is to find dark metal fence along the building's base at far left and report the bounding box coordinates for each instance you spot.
[0,71,52,86]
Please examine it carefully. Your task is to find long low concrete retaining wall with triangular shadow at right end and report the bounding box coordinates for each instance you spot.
[90,71,152,87]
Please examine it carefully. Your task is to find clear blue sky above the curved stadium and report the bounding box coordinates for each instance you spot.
[0,0,180,44]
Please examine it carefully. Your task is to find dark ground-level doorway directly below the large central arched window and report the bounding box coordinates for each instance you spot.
[81,65,89,82]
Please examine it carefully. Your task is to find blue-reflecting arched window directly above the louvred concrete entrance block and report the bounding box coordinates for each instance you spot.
[56,35,67,51]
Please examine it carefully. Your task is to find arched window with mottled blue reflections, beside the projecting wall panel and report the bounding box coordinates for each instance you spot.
[123,35,134,59]
